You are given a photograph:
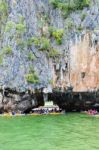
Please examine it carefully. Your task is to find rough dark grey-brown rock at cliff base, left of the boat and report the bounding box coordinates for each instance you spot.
[0,89,44,113]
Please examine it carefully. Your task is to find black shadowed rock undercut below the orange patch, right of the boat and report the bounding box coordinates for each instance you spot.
[49,91,99,112]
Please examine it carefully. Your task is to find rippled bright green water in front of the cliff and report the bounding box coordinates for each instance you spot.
[0,114,99,150]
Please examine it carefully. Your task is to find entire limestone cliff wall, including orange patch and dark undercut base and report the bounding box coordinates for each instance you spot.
[0,0,99,111]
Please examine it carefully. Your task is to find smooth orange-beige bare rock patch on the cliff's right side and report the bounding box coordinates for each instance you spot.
[70,32,99,92]
